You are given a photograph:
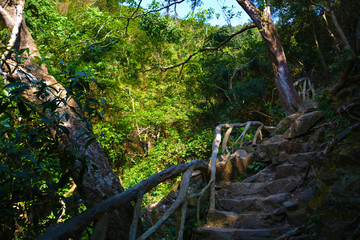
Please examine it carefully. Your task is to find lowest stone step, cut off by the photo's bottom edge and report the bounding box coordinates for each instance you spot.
[194,227,291,240]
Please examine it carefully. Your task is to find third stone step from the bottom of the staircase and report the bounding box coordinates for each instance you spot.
[217,193,290,214]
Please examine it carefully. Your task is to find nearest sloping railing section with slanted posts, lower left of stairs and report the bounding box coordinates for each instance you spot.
[38,159,210,240]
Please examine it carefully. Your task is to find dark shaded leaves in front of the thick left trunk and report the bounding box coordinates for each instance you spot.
[0,50,95,239]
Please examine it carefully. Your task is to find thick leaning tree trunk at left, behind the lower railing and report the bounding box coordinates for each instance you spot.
[0,0,133,239]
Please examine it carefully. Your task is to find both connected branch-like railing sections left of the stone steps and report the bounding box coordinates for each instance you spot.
[38,121,264,240]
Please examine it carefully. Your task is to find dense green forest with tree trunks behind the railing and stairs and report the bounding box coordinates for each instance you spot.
[0,0,360,239]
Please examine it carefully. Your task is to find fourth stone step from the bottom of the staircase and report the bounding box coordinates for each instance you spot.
[217,177,301,200]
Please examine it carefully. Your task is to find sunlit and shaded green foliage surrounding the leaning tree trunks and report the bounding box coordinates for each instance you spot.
[4,0,358,238]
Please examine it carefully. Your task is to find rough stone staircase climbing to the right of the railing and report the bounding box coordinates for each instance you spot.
[193,139,319,240]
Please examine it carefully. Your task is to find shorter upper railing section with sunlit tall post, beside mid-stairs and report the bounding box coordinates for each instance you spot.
[209,121,264,211]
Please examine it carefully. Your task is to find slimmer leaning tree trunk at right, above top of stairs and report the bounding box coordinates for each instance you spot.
[237,0,301,114]
